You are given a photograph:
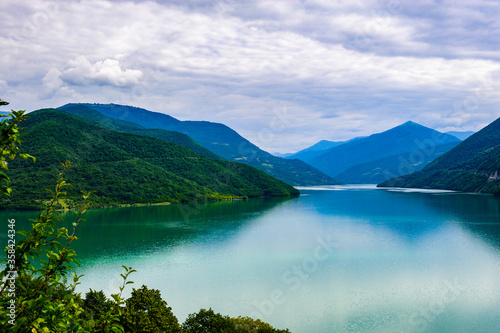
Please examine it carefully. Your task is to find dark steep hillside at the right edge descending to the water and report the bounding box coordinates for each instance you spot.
[379,118,500,193]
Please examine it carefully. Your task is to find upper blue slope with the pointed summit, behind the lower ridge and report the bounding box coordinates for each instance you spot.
[310,121,460,181]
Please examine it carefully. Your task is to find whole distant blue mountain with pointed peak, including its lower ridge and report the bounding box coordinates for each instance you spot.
[294,121,460,184]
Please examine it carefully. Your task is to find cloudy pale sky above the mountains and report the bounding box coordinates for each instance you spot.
[0,0,500,153]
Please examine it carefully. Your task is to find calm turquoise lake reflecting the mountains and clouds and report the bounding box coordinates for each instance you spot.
[0,185,500,333]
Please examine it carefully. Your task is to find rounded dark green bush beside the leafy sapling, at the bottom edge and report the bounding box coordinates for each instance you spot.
[122,285,182,333]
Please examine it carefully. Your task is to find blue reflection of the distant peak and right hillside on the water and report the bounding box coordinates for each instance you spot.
[300,189,500,247]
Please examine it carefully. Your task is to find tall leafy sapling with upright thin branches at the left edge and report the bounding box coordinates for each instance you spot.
[0,100,134,332]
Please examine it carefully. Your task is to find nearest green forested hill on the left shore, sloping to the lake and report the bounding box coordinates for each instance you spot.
[0,109,298,208]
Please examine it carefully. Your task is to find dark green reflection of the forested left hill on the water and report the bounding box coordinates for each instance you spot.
[64,198,292,258]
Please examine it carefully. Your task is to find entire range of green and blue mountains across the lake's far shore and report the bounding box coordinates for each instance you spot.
[2,99,490,197]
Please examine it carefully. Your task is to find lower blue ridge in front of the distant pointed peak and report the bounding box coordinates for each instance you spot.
[337,141,459,184]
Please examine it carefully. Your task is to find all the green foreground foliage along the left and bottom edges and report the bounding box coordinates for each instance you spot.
[0,100,288,333]
